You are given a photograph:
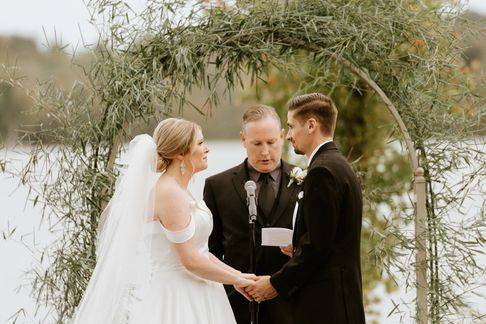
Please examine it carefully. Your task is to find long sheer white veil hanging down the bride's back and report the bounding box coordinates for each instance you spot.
[72,135,159,324]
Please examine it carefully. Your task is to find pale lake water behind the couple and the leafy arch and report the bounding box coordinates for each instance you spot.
[0,141,486,323]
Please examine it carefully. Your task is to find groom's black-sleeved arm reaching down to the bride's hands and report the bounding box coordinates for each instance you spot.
[270,167,341,296]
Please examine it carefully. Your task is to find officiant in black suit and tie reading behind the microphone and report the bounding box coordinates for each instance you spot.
[204,105,300,324]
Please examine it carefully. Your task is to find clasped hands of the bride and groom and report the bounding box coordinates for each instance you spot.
[234,273,278,302]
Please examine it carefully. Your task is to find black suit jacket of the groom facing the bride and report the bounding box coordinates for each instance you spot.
[270,142,365,324]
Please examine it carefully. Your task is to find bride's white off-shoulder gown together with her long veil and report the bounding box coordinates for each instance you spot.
[70,135,236,324]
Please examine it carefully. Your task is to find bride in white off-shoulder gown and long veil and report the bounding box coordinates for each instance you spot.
[72,118,255,324]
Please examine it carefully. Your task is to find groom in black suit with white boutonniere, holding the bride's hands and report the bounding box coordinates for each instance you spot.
[247,93,365,324]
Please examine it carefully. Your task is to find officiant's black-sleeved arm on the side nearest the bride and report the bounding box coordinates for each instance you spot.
[203,179,224,260]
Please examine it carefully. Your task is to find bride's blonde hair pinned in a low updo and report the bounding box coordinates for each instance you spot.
[153,118,200,172]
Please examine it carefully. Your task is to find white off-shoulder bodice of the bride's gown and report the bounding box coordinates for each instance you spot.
[147,200,213,271]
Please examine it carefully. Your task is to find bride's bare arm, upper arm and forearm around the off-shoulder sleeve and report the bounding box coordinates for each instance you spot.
[155,186,252,287]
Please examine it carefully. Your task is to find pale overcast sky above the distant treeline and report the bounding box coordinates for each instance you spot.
[0,0,486,51]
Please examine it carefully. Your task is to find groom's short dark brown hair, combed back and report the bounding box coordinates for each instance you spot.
[288,92,338,136]
